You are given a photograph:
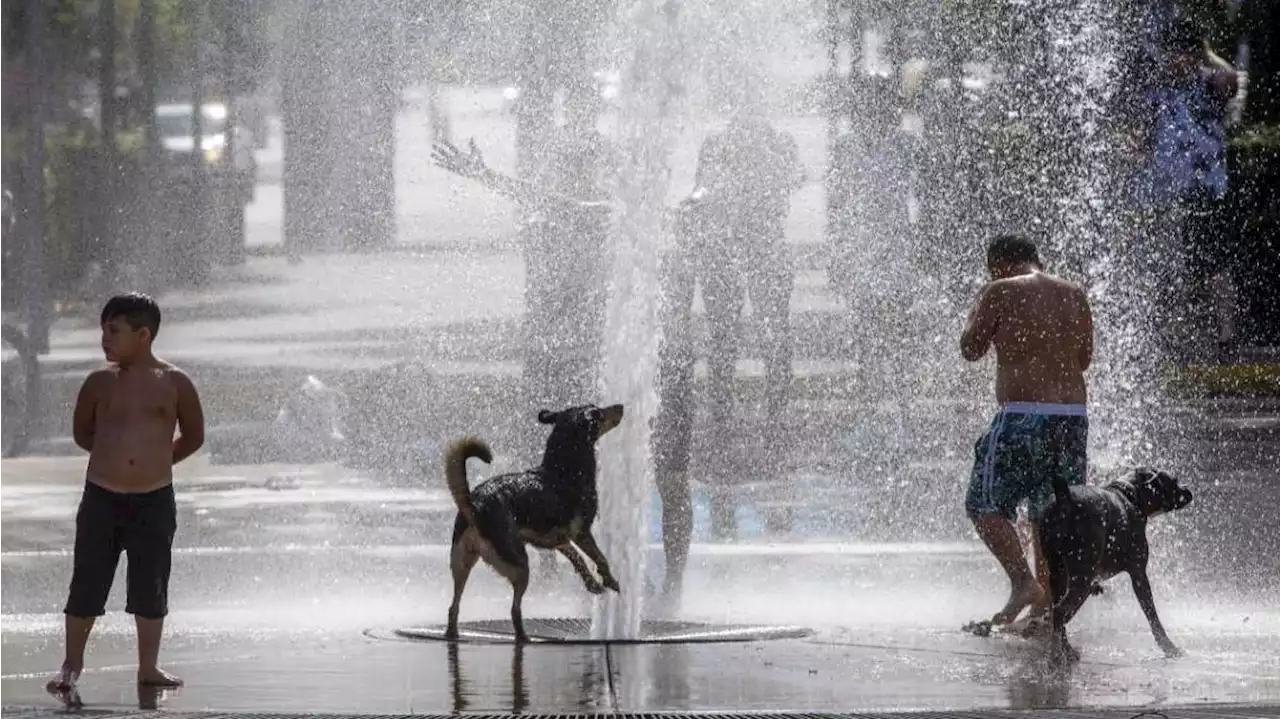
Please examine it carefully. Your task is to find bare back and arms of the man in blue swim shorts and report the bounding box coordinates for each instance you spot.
[963,270,1093,404]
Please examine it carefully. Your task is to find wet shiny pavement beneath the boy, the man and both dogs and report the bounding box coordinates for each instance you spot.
[0,458,1280,714]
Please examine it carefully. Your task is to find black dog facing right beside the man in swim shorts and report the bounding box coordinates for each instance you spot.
[1041,467,1192,661]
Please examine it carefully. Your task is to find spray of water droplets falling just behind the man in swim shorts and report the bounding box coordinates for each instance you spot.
[1038,0,1161,470]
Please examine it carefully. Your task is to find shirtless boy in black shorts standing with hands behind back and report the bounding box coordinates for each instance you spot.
[49,293,205,692]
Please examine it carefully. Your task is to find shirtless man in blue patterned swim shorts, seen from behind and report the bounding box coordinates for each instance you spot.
[960,235,1093,624]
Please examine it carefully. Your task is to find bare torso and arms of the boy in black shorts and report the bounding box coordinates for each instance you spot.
[74,360,198,493]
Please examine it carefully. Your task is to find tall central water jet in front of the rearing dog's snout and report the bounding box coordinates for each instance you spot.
[591,0,676,638]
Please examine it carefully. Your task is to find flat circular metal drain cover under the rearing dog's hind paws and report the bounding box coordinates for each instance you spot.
[396,618,813,644]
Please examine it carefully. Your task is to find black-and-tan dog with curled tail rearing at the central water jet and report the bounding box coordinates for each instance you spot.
[444,404,622,642]
